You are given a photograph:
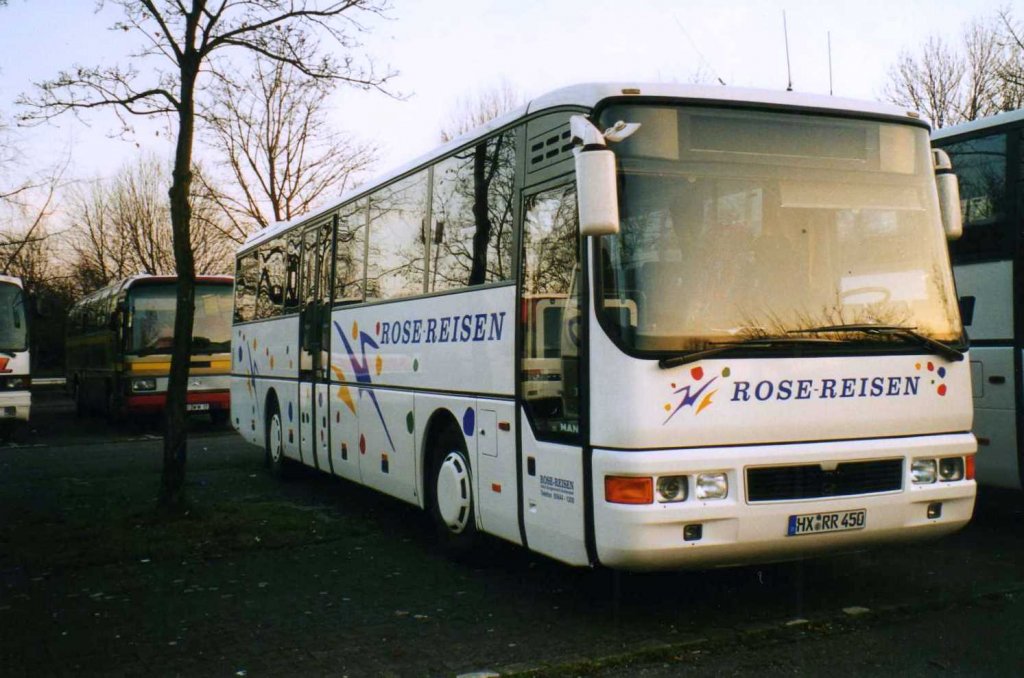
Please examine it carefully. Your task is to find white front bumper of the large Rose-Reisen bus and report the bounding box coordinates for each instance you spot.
[592,433,977,569]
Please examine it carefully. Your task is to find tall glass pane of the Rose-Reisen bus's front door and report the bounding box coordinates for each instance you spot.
[520,184,580,440]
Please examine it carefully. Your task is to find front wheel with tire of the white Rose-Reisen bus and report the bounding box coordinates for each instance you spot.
[430,428,477,557]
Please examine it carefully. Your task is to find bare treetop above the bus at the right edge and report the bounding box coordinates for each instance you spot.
[885,11,1024,127]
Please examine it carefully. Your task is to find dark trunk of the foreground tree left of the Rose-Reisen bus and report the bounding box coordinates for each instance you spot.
[158,59,199,514]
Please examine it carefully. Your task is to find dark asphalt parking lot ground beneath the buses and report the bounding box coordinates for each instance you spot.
[0,391,1024,676]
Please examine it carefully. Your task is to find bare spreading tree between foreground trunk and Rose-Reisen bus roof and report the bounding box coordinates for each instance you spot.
[204,58,376,242]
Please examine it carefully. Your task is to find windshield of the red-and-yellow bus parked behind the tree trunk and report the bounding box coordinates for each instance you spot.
[128,283,232,355]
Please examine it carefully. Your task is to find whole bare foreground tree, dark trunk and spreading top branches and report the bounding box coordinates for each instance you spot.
[20,0,395,512]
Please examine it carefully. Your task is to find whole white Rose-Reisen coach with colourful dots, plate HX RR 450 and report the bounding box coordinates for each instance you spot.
[231,84,976,569]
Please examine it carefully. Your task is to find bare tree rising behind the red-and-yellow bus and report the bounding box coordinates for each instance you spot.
[68,156,233,292]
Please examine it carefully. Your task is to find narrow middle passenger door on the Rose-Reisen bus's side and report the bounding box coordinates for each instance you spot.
[299,221,334,472]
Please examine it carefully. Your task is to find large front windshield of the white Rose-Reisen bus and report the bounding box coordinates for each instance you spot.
[598,105,962,351]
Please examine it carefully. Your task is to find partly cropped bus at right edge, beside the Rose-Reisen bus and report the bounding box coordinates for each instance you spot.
[932,110,1024,489]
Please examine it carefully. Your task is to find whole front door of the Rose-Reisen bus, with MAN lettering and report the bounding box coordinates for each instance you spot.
[519,183,589,565]
